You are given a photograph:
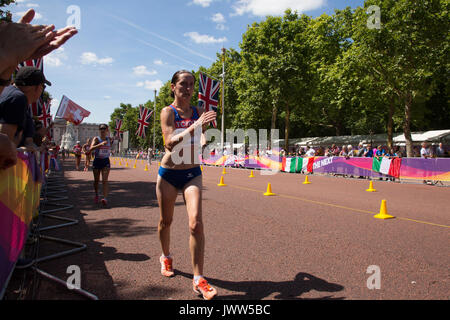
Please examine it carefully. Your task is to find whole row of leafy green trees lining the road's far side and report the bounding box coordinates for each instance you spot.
[107,0,450,156]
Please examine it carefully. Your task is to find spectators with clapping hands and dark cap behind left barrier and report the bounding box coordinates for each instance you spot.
[0,9,77,170]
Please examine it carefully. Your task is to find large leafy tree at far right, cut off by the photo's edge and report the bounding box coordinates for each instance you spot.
[353,0,450,157]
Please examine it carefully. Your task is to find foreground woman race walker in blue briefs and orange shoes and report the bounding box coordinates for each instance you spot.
[156,70,217,300]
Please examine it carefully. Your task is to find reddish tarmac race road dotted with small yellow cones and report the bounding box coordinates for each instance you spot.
[15,158,450,300]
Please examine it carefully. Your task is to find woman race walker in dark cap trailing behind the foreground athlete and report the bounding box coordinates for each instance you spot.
[89,124,113,206]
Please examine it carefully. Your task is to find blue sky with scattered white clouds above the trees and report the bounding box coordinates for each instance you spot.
[6,0,364,123]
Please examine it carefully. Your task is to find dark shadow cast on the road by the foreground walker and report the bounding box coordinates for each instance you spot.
[175,270,345,300]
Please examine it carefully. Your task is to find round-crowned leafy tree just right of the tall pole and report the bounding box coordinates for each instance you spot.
[240,10,309,148]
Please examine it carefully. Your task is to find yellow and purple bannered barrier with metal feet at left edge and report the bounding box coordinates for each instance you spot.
[0,152,98,300]
